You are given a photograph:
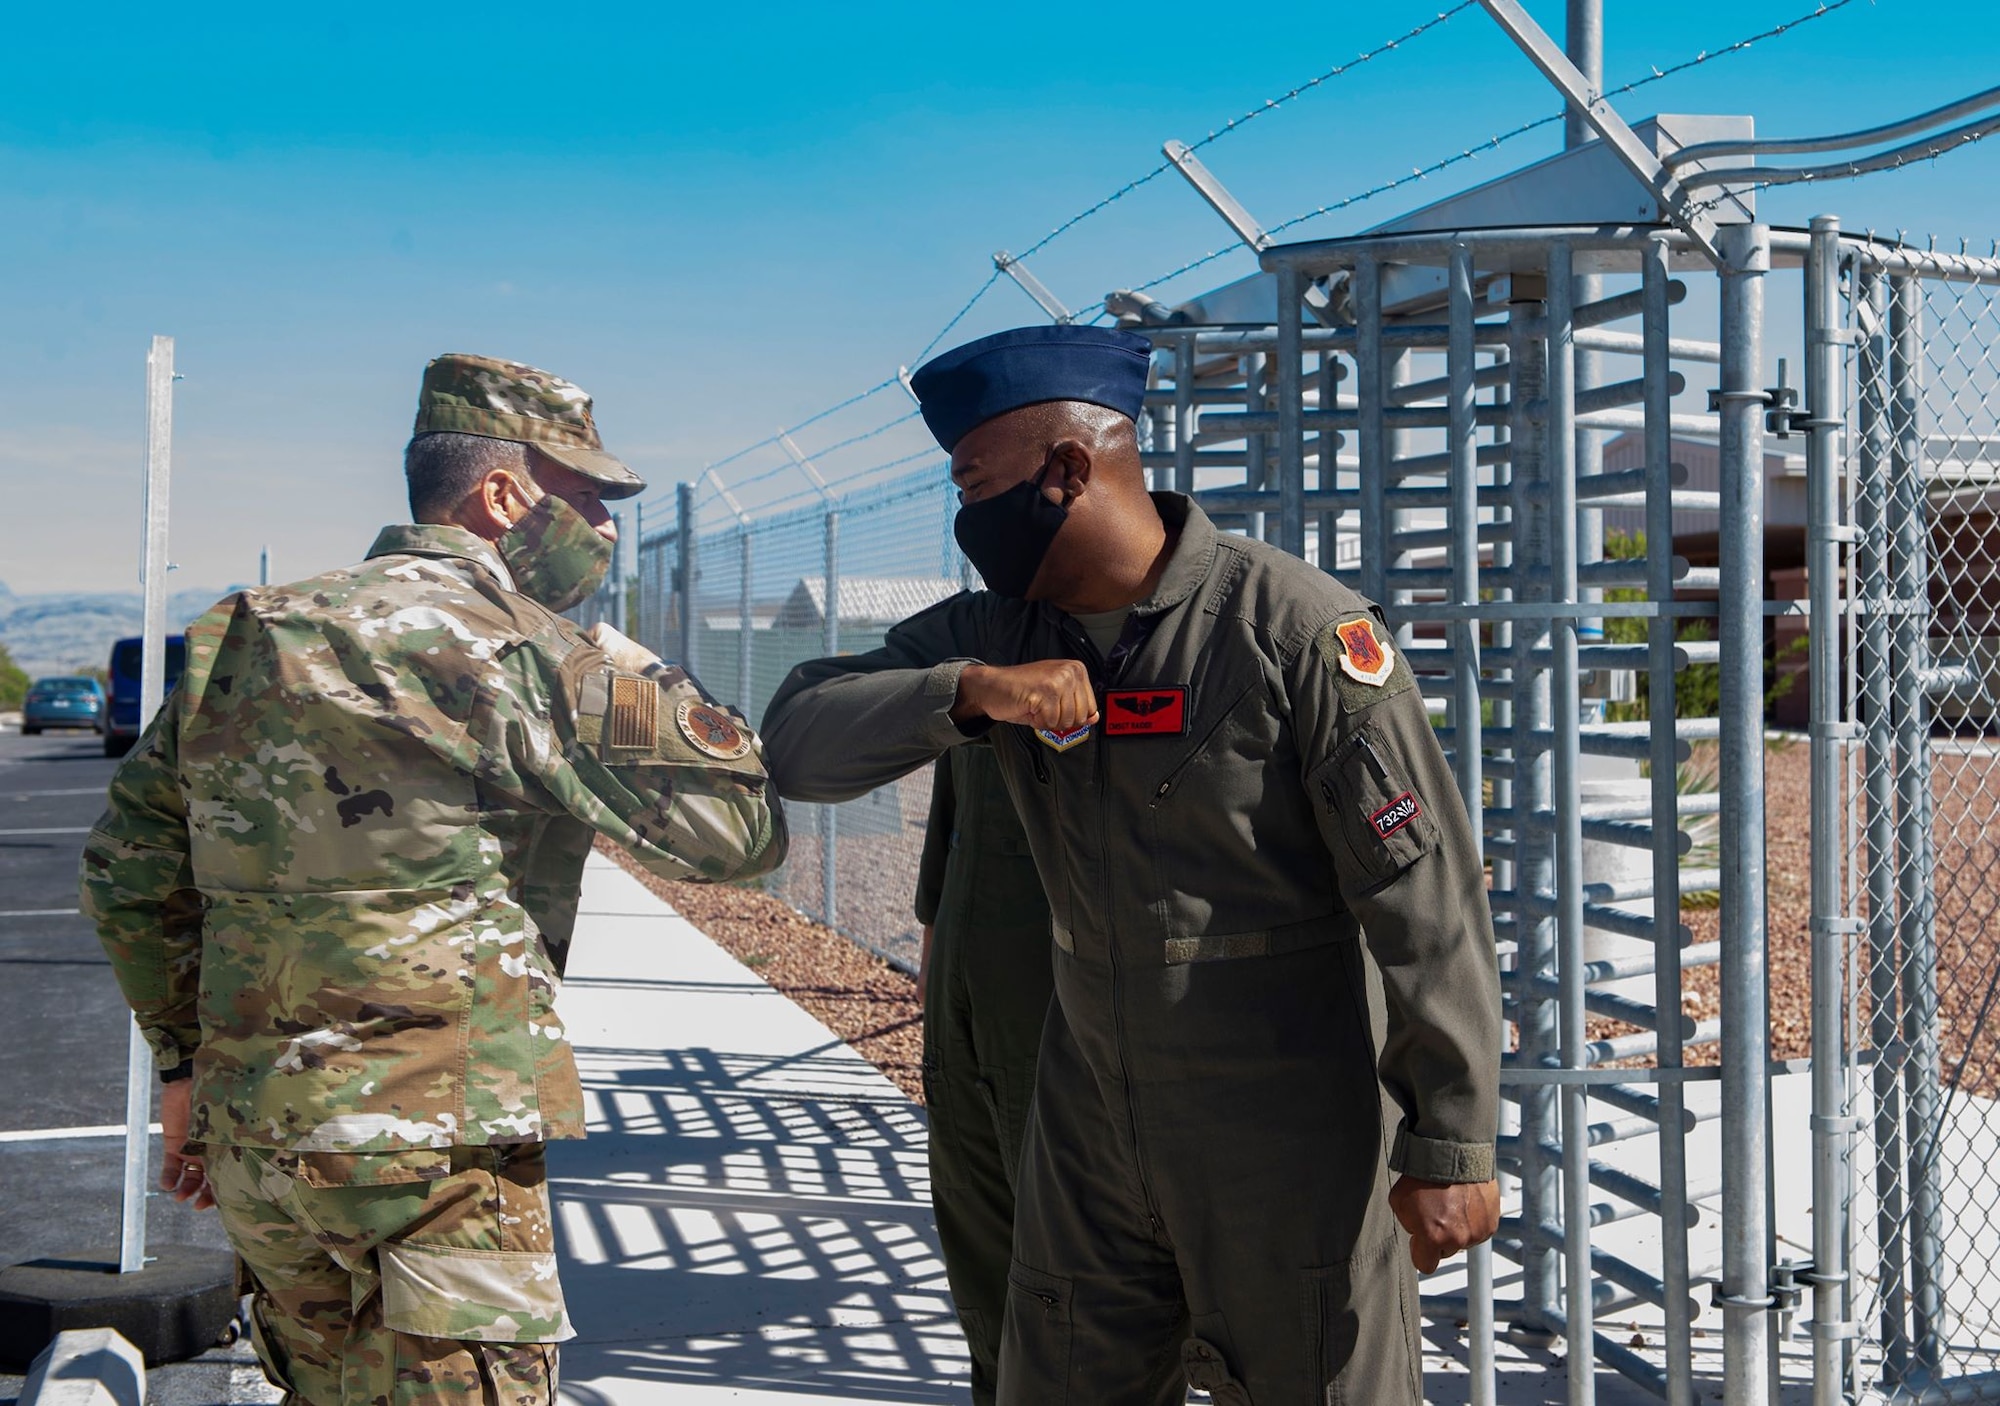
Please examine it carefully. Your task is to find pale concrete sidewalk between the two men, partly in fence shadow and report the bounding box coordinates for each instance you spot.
[550,856,970,1406]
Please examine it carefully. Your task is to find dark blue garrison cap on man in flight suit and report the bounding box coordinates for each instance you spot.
[910,322,1152,454]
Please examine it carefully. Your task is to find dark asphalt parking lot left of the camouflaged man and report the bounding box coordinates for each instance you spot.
[0,728,268,1406]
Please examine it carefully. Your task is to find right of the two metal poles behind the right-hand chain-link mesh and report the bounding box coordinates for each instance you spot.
[1888,274,1944,1376]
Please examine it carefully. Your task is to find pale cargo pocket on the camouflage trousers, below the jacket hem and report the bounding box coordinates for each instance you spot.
[376,1242,576,1342]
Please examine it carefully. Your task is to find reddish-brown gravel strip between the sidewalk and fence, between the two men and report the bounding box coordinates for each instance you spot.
[598,840,924,1102]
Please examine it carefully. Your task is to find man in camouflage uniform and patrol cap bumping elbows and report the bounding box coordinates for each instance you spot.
[82,356,784,1406]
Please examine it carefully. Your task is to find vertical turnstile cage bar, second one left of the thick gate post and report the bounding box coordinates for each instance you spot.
[1546,240,1598,1406]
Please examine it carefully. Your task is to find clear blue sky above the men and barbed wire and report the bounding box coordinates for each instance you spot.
[0,0,2000,592]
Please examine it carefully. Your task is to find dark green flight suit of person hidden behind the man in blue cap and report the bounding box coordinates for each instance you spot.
[916,746,1056,1406]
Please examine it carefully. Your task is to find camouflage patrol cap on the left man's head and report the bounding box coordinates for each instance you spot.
[410,352,646,498]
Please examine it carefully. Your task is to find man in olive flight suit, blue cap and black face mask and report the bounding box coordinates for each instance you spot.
[764,326,1502,1406]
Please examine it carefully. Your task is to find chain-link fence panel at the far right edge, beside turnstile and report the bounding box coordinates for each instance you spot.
[1844,244,2000,1400]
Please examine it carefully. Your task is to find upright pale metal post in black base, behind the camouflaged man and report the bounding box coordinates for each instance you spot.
[118,336,174,1274]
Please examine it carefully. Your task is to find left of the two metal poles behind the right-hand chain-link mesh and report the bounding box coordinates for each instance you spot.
[1854,266,1910,1384]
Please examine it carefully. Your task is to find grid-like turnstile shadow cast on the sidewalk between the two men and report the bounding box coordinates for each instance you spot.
[550,1048,966,1406]
